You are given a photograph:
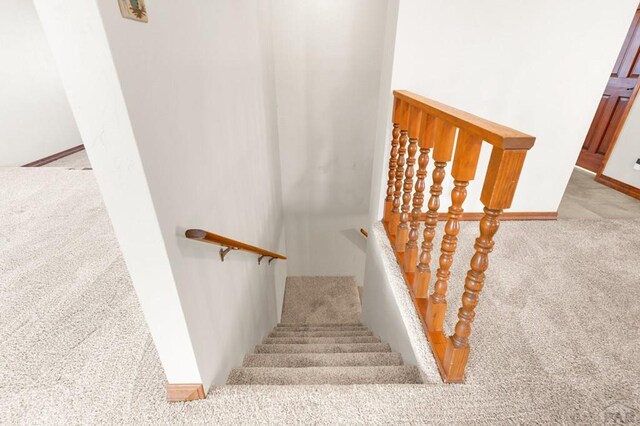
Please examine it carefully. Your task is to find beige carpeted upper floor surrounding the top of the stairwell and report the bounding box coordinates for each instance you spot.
[0,168,640,425]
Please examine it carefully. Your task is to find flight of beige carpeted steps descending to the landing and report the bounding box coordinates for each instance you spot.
[227,324,422,385]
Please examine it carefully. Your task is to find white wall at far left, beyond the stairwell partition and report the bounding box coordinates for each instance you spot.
[0,0,82,166]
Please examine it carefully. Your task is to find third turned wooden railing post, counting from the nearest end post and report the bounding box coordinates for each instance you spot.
[414,118,456,299]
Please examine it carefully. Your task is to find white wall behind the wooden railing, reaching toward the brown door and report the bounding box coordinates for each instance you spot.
[372,0,637,218]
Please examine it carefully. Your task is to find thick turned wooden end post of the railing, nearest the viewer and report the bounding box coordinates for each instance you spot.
[443,147,527,381]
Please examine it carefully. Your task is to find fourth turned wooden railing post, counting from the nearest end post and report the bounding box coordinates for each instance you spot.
[404,113,435,279]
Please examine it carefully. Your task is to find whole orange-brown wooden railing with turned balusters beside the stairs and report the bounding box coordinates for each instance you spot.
[383,90,535,383]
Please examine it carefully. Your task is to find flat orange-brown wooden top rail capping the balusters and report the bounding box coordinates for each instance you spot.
[393,90,536,150]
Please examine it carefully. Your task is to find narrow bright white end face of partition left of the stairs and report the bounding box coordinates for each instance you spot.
[35,0,202,383]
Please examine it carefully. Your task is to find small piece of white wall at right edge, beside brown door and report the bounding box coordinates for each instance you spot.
[603,102,640,188]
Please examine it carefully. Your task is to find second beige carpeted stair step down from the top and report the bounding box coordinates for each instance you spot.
[242,352,402,368]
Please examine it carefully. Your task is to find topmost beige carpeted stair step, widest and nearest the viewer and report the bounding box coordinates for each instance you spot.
[227,365,422,385]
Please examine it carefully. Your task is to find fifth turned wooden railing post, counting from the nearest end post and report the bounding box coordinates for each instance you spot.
[395,106,422,253]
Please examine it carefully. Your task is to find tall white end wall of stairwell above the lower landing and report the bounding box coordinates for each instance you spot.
[272,0,387,284]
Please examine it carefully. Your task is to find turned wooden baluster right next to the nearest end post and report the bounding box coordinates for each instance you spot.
[426,129,482,332]
